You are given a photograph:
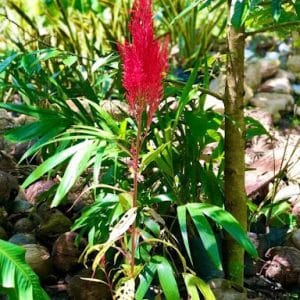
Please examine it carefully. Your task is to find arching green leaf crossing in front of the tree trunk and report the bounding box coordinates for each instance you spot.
[192,203,258,257]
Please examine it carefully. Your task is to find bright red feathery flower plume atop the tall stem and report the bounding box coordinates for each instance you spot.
[119,0,168,126]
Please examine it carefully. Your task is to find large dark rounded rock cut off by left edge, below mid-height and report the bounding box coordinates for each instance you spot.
[0,171,19,211]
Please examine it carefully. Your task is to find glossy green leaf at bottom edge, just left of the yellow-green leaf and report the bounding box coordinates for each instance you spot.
[152,255,180,300]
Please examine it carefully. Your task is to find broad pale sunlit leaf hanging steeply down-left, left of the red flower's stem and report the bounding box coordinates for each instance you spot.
[51,140,97,207]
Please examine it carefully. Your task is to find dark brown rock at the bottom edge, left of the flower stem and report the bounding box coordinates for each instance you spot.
[68,270,112,300]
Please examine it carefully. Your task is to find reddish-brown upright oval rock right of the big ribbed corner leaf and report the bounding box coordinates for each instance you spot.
[52,232,85,272]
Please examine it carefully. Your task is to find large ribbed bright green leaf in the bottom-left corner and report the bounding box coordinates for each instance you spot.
[0,240,50,300]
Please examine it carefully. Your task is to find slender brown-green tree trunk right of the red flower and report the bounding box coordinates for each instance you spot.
[224,0,247,285]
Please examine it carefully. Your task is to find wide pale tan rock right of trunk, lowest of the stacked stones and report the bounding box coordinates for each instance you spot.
[250,93,294,116]
